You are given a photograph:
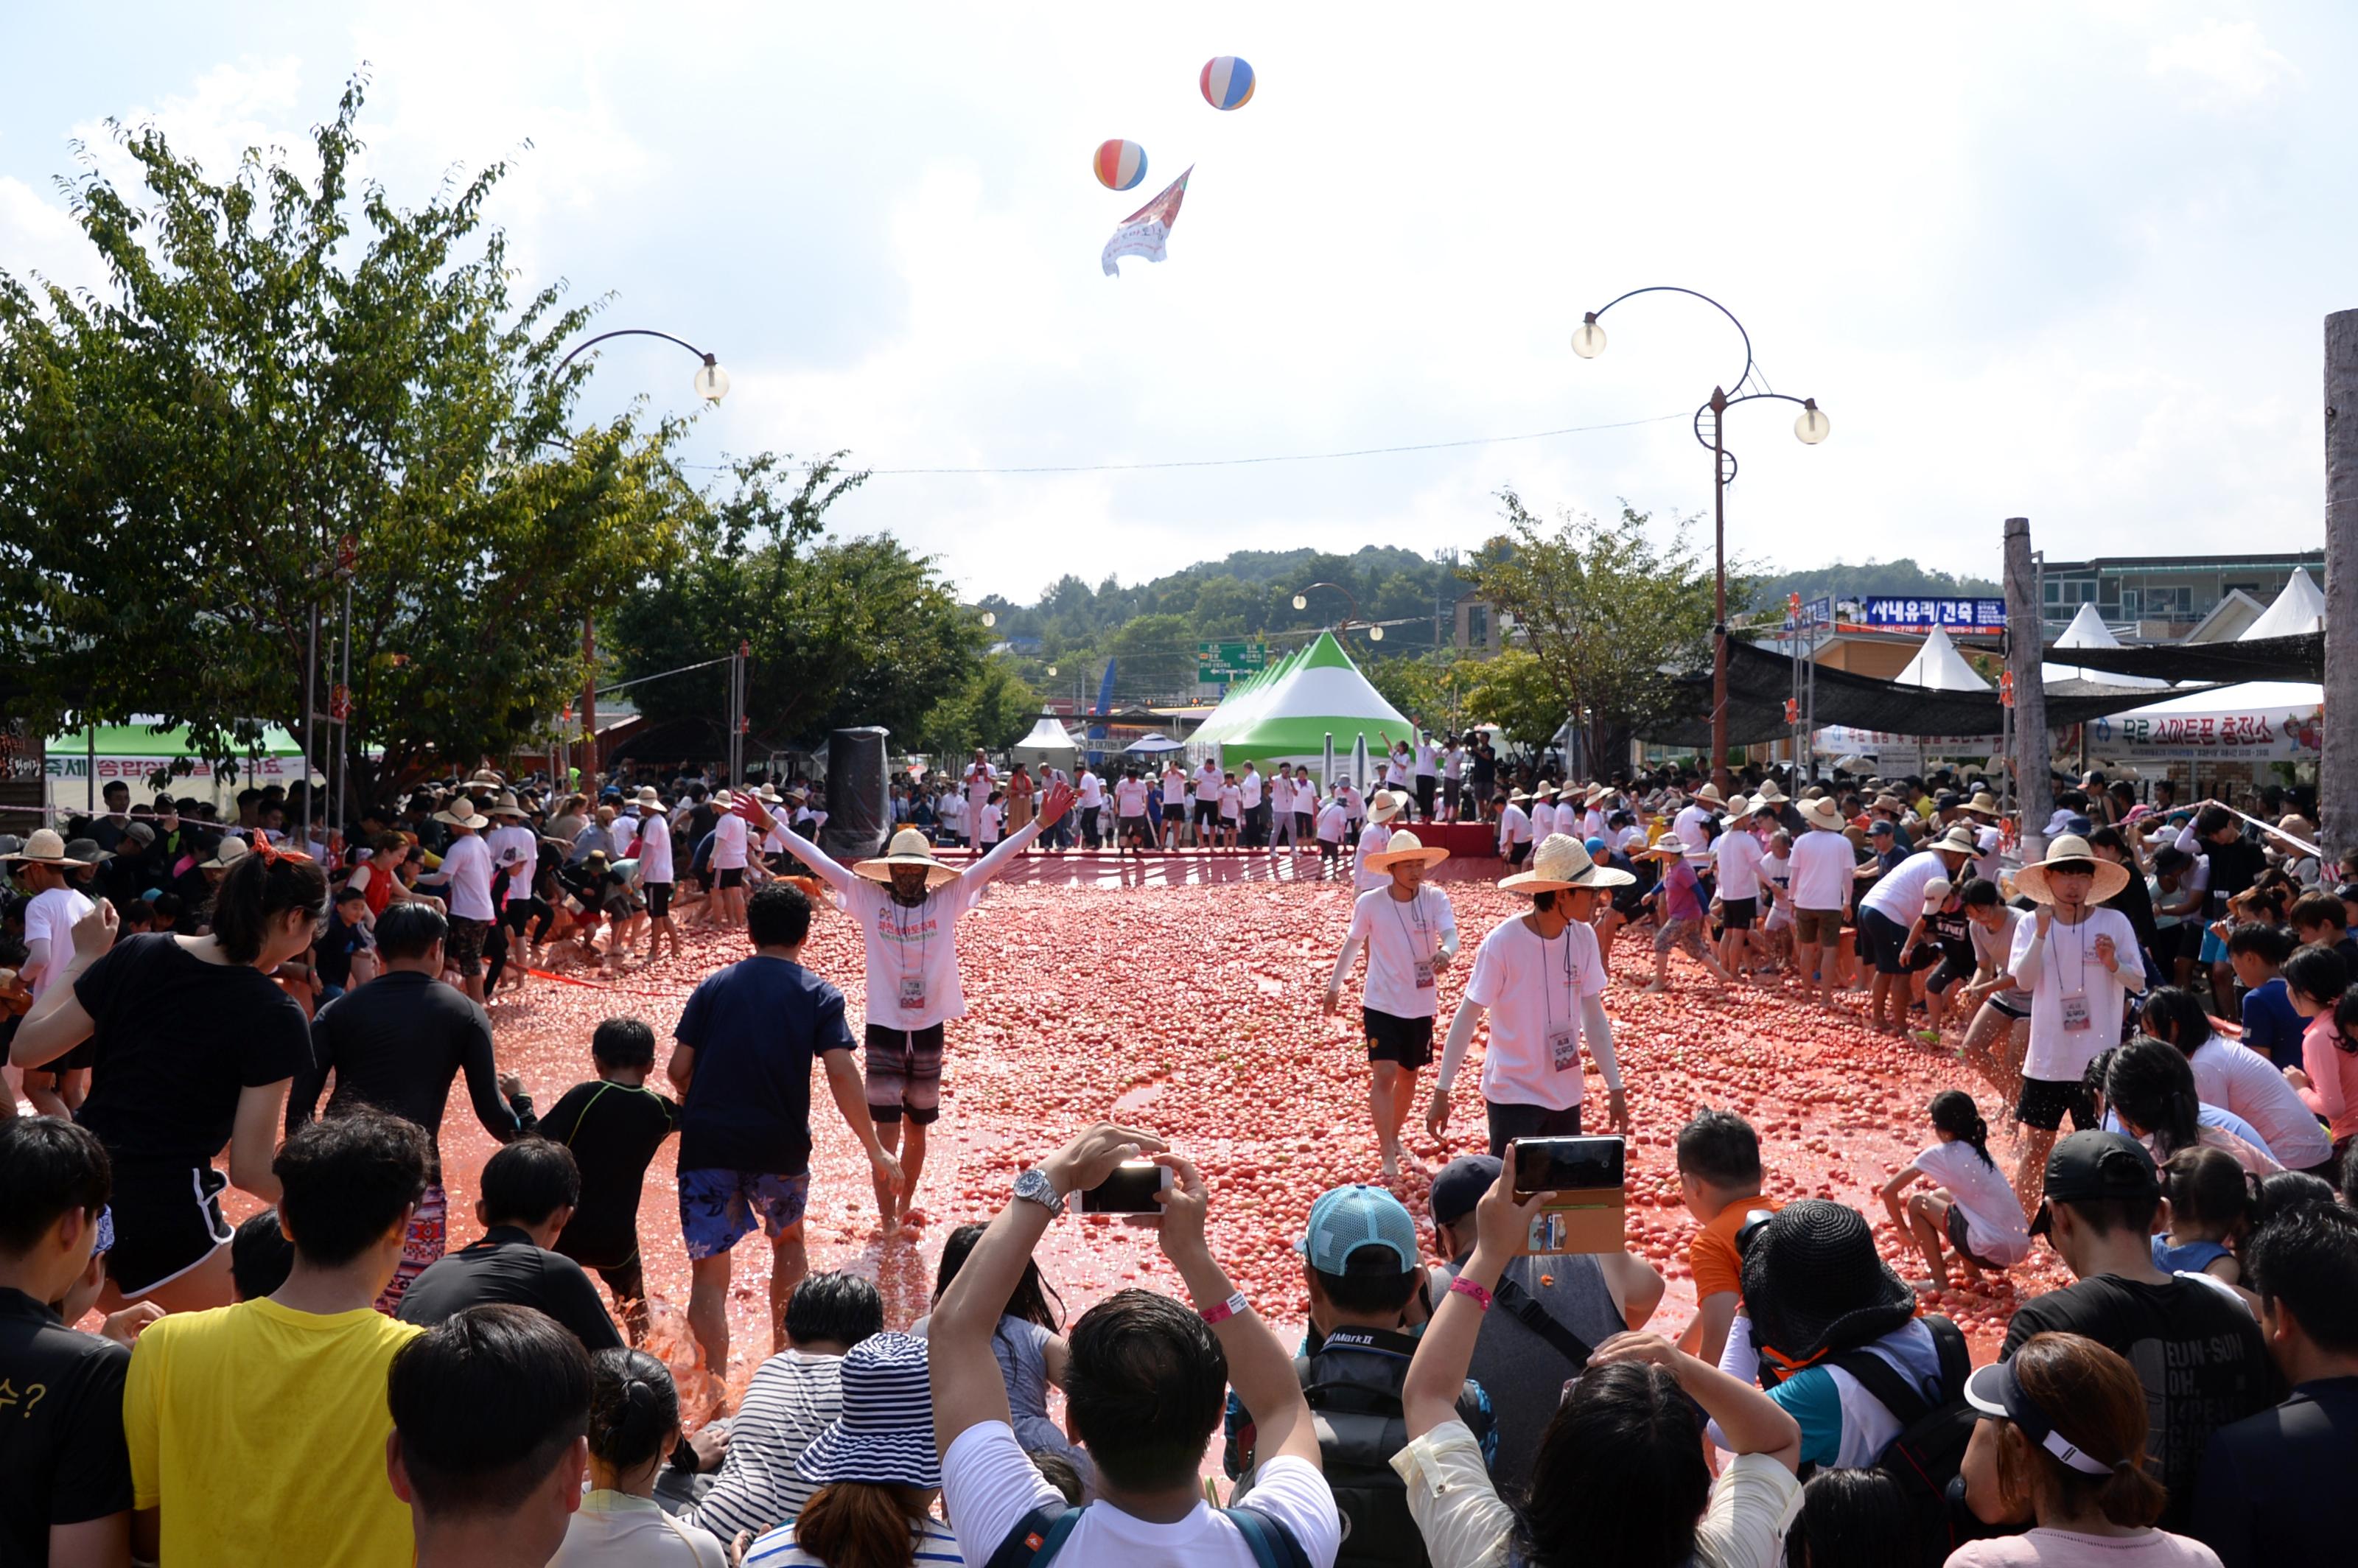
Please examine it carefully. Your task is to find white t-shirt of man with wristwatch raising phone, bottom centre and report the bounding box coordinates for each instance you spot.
[941,1422,1342,1568]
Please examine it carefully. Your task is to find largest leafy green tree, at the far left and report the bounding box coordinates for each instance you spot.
[0,80,696,792]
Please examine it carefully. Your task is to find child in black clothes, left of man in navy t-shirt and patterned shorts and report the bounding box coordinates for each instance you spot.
[540,1018,679,1344]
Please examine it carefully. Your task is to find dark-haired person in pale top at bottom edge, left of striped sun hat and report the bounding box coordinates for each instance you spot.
[550,1351,729,1568]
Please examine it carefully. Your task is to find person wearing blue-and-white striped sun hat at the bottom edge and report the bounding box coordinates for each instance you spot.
[745,1334,967,1568]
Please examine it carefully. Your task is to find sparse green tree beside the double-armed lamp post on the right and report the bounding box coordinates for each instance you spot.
[1464,491,1749,757]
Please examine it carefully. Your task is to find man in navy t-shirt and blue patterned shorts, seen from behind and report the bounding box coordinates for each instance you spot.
[665,882,900,1377]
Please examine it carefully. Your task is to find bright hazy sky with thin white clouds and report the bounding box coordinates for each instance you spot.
[0,0,2358,601]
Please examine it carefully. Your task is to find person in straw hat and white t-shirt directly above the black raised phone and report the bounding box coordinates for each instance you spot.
[1424,833,1634,1155]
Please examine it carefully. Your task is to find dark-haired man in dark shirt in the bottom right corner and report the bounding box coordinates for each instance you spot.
[2193,1203,2358,1568]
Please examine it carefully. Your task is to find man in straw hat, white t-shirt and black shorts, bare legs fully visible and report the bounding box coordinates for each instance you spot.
[1325,827,1458,1177]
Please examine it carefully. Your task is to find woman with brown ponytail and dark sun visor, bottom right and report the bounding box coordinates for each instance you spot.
[1948,1334,2219,1568]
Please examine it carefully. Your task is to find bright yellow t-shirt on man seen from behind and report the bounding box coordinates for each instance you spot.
[122,1299,424,1568]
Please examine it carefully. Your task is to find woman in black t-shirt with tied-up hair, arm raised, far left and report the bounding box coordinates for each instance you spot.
[10,835,328,1313]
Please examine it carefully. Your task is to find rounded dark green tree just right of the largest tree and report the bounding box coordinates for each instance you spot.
[613,452,988,745]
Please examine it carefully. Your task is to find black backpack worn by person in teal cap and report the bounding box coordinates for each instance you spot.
[1295,1328,1490,1568]
